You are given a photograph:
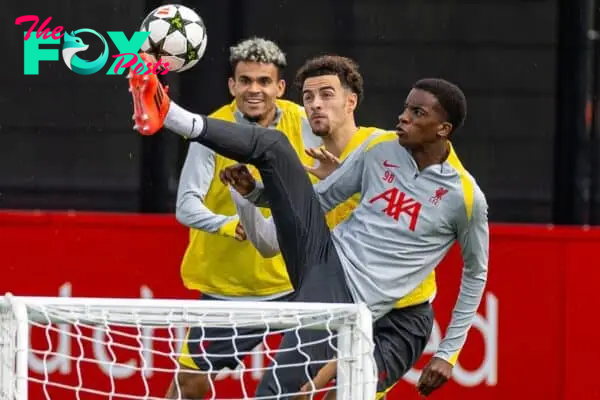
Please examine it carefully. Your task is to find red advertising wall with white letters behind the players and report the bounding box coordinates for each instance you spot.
[0,212,600,400]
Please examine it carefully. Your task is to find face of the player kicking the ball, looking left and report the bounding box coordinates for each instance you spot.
[396,89,452,149]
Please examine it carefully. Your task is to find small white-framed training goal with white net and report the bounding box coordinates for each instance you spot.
[0,294,377,400]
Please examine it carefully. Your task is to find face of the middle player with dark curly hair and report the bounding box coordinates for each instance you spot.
[302,75,357,137]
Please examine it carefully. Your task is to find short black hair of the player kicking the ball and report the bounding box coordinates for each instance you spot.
[413,78,467,132]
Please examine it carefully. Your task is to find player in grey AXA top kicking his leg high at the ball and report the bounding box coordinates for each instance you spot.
[130,59,489,396]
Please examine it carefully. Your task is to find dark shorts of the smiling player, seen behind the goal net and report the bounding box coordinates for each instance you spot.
[178,294,289,372]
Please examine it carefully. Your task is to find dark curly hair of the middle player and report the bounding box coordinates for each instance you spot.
[295,55,364,103]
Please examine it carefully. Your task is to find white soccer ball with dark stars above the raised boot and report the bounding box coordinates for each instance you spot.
[141,4,207,72]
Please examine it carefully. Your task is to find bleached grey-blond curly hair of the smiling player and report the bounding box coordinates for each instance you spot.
[229,37,287,72]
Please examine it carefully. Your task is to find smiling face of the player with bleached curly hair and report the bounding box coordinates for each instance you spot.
[229,61,285,123]
